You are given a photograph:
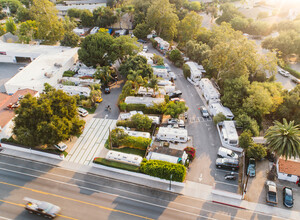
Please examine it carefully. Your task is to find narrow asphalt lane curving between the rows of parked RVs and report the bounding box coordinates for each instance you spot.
[148,44,238,192]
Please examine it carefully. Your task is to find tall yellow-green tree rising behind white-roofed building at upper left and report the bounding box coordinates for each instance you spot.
[30,0,64,44]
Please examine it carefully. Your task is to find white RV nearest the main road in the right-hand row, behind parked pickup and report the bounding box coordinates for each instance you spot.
[220,121,239,147]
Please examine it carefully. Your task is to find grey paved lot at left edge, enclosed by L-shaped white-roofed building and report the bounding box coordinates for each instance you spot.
[0,63,25,92]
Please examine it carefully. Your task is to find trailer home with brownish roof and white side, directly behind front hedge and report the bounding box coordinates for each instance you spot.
[146,146,188,164]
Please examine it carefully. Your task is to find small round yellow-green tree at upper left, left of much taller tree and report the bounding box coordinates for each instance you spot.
[17,20,38,44]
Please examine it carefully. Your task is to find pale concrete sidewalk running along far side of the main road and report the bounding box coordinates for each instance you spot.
[0,149,300,220]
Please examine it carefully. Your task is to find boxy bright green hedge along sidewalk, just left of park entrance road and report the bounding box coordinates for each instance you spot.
[140,159,186,182]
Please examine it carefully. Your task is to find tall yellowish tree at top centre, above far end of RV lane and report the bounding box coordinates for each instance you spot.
[147,0,179,41]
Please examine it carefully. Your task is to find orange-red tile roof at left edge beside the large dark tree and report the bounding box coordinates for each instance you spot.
[0,89,38,128]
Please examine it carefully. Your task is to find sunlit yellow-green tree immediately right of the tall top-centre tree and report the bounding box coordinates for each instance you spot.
[178,11,203,45]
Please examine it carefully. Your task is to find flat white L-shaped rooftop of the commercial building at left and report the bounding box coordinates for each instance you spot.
[0,42,78,94]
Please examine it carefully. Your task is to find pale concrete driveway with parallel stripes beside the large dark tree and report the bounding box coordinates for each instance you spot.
[65,118,117,165]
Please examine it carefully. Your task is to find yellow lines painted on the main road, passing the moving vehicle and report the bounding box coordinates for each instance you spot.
[0,181,152,220]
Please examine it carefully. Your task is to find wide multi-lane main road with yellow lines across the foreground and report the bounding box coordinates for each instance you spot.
[0,155,279,220]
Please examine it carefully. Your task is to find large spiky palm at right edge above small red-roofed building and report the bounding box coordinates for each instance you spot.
[265,118,300,159]
